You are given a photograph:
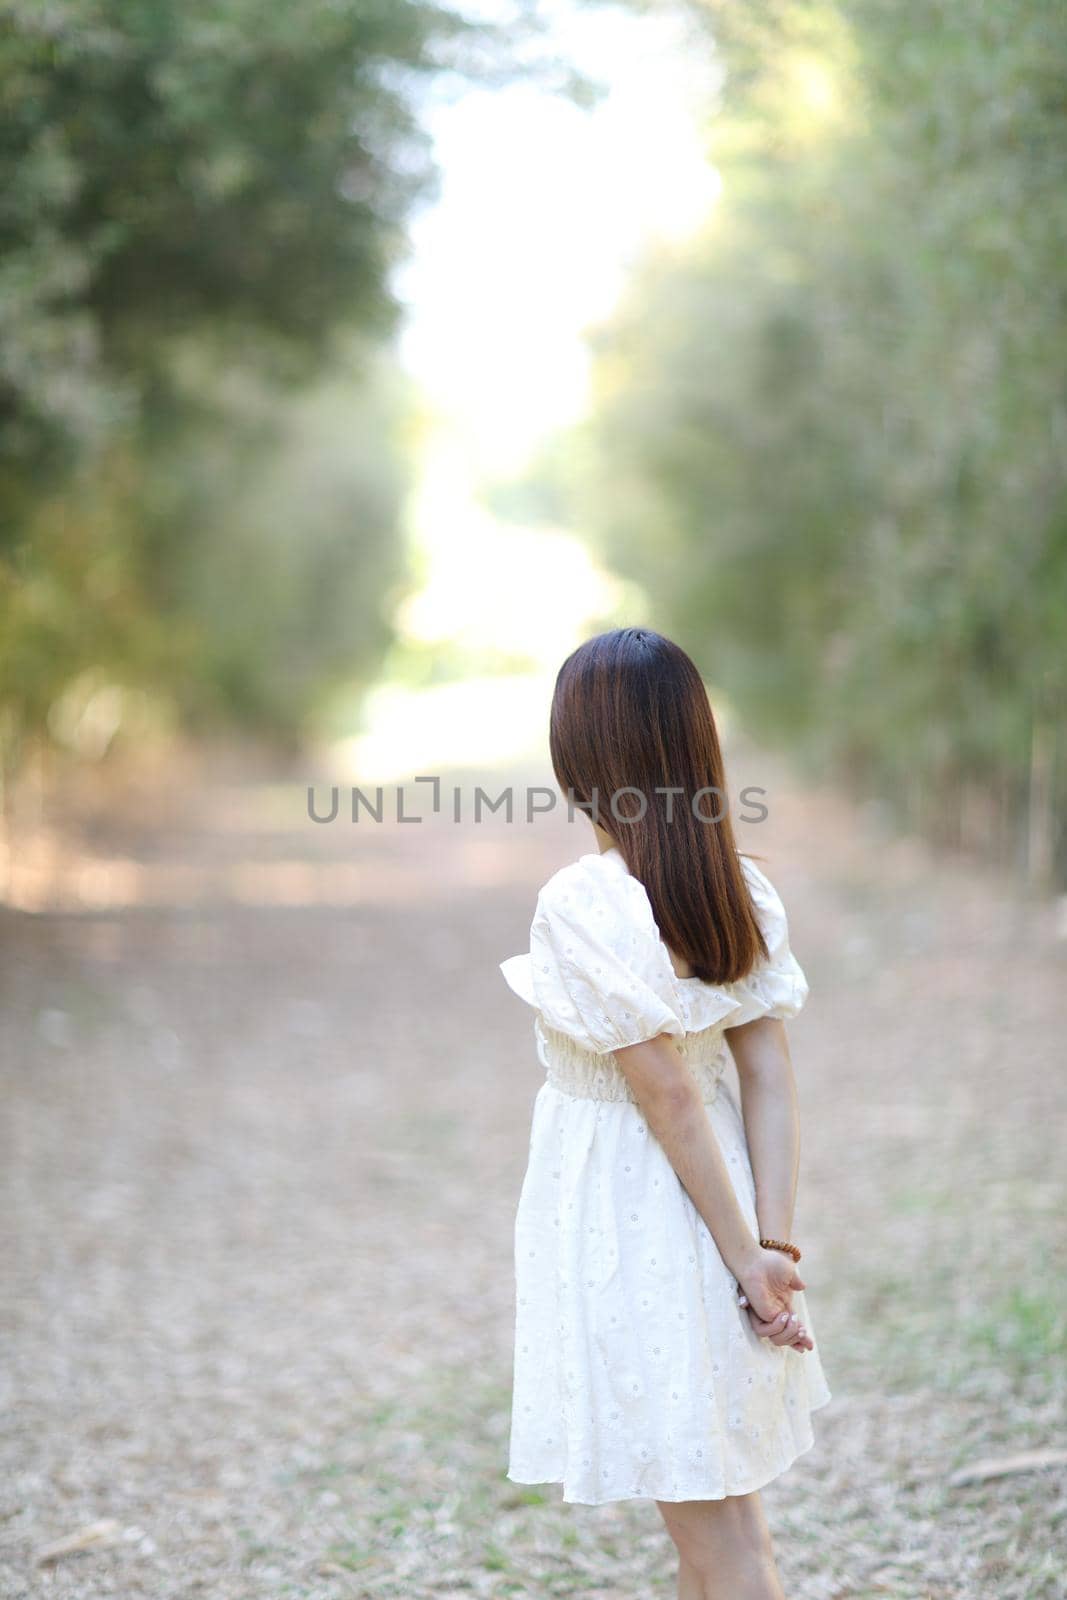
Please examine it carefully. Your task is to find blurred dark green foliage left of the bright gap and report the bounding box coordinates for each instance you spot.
[0,0,566,774]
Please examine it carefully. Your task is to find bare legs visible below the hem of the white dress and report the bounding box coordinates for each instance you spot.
[656,1490,785,1600]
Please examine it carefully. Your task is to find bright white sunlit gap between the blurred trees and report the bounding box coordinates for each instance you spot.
[347,5,720,779]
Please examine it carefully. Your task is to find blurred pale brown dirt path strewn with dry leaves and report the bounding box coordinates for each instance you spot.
[0,739,1067,1600]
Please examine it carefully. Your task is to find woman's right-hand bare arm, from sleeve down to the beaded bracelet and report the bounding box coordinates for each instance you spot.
[726,1016,800,1238]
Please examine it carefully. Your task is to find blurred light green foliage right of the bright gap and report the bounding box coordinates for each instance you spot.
[569,0,1067,882]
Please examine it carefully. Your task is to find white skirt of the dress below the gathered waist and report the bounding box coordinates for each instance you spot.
[507,1082,830,1506]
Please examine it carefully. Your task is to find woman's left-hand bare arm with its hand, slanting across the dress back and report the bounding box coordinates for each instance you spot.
[604,1034,805,1322]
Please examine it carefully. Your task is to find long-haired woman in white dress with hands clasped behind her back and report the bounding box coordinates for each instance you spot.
[501,627,830,1600]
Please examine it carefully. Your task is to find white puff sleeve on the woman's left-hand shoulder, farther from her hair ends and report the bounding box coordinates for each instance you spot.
[530,861,685,1056]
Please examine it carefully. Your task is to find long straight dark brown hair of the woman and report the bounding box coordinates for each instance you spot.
[549,627,768,984]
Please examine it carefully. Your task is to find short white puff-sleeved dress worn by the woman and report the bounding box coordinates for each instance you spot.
[499,848,830,1506]
